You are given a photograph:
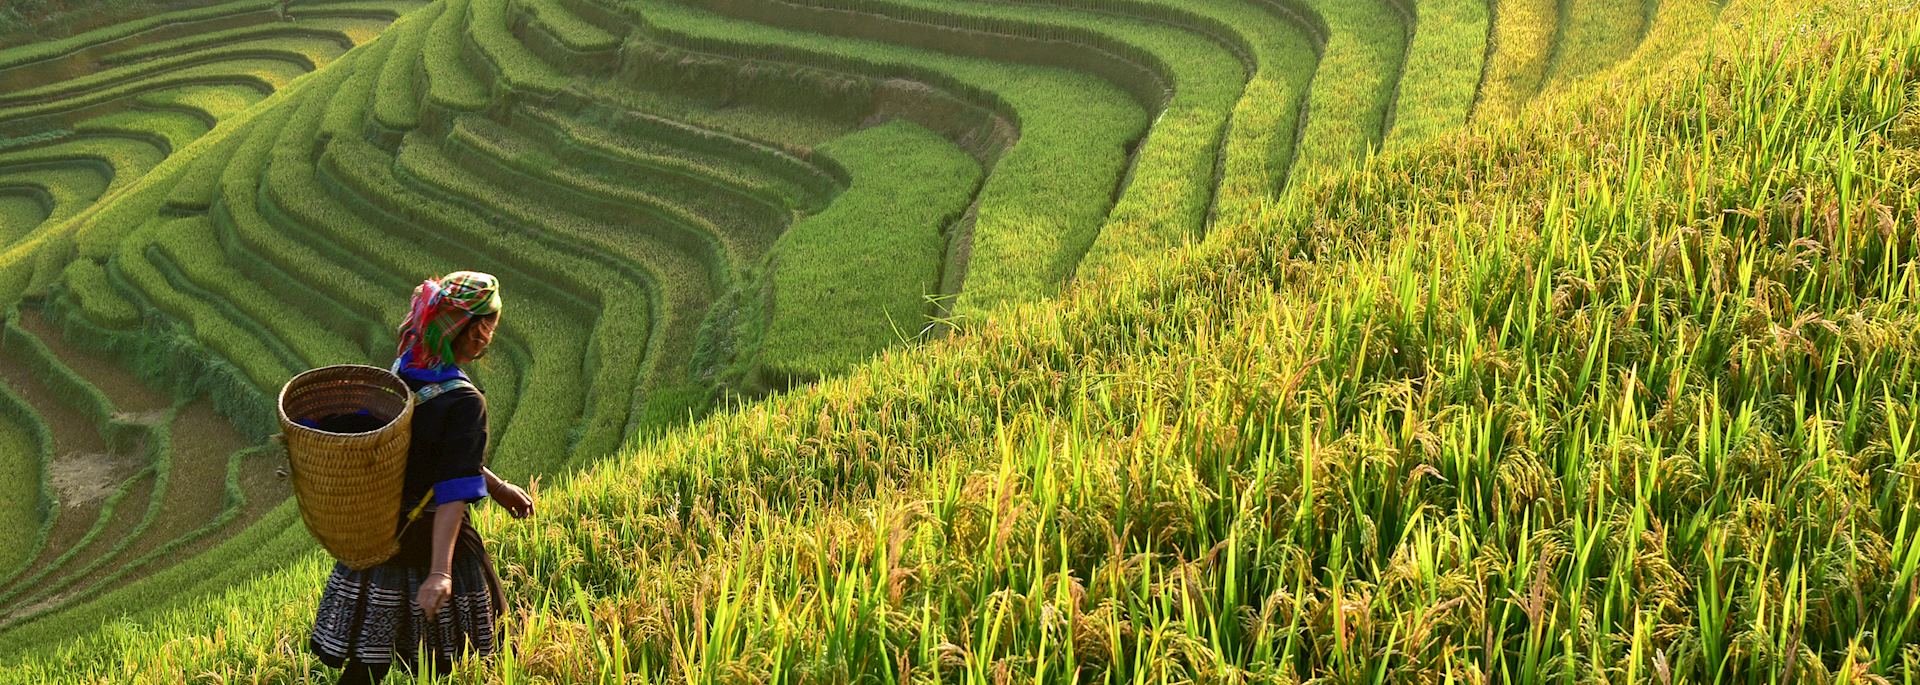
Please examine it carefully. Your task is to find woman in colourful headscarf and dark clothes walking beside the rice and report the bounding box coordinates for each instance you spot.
[307,271,534,683]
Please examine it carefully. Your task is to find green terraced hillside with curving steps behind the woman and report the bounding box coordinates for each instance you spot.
[0,0,1720,660]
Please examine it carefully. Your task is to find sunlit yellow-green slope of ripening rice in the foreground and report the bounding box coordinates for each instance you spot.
[0,2,1920,681]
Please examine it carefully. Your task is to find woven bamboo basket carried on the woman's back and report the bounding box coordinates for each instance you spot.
[280,365,413,570]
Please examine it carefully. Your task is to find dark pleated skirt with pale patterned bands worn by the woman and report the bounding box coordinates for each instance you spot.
[307,516,505,672]
